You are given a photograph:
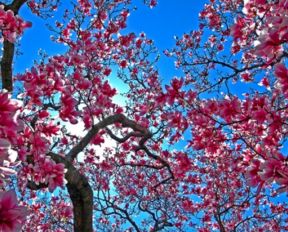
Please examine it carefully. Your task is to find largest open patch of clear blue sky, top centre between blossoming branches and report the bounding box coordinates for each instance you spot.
[128,0,207,79]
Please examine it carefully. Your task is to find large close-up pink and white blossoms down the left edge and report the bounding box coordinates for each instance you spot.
[0,91,27,231]
